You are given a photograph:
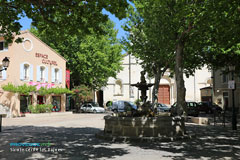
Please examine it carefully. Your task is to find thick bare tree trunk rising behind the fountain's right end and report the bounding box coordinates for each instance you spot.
[175,40,187,116]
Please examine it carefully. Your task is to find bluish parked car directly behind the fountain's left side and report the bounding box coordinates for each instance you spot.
[111,101,137,112]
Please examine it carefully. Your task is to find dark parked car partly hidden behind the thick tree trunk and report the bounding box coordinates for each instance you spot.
[170,101,199,117]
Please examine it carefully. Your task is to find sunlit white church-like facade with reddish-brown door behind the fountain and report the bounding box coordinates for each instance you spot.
[103,55,211,105]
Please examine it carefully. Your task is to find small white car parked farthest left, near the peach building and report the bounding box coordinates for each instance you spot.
[81,102,105,113]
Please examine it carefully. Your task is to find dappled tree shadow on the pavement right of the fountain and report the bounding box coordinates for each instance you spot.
[126,125,240,160]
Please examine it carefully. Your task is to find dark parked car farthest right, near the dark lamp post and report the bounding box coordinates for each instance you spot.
[198,102,223,113]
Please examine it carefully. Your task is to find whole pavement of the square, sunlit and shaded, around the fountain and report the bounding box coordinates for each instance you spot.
[0,114,240,160]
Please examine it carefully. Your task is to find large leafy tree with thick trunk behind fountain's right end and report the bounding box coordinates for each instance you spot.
[125,0,240,115]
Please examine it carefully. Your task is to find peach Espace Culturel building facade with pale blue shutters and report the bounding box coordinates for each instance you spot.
[0,31,66,116]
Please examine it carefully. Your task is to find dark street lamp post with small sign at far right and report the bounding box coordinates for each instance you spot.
[229,66,237,130]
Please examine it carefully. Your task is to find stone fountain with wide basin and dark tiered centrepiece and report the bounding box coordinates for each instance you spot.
[97,71,186,141]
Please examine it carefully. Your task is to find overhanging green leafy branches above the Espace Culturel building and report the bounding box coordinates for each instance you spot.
[0,0,128,42]
